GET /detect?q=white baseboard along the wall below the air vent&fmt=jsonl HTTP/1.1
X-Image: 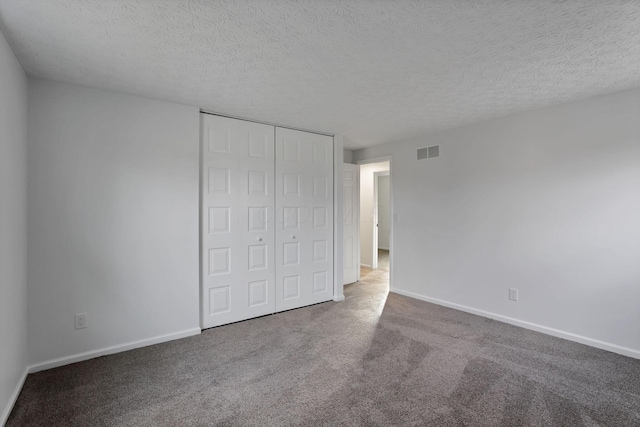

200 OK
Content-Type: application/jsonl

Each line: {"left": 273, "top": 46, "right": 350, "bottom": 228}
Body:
{"left": 392, "top": 289, "right": 640, "bottom": 359}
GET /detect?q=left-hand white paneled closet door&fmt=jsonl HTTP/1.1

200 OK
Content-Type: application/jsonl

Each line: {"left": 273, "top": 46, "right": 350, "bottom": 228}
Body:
{"left": 200, "top": 114, "right": 275, "bottom": 328}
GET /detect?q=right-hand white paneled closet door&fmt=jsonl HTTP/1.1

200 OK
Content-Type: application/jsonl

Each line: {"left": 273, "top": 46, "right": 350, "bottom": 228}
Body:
{"left": 276, "top": 127, "right": 333, "bottom": 311}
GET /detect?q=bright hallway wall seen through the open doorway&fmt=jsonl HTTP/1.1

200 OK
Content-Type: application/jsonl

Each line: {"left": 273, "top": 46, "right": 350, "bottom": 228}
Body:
{"left": 360, "top": 162, "right": 389, "bottom": 267}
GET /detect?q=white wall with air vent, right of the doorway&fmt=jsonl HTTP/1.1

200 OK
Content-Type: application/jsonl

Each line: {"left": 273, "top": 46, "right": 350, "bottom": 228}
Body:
{"left": 354, "top": 90, "right": 640, "bottom": 357}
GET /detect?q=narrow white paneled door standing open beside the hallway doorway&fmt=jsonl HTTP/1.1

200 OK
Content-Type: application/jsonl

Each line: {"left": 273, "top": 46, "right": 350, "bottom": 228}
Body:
{"left": 342, "top": 163, "right": 360, "bottom": 285}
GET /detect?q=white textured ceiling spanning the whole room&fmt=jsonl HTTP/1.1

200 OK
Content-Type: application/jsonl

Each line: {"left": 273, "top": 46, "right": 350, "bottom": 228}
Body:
{"left": 0, "top": 0, "right": 640, "bottom": 148}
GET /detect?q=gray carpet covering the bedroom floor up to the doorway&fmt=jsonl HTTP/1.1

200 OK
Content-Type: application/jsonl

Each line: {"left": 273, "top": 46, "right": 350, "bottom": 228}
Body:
{"left": 8, "top": 260, "right": 640, "bottom": 426}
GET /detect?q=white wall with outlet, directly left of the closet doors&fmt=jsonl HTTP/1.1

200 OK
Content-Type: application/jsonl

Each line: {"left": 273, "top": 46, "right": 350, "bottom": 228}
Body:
{"left": 28, "top": 79, "right": 199, "bottom": 369}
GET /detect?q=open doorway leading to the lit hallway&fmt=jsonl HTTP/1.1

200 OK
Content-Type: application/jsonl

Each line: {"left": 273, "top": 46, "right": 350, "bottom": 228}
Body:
{"left": 359, "top": 160, "right": 392, "bottom": 286}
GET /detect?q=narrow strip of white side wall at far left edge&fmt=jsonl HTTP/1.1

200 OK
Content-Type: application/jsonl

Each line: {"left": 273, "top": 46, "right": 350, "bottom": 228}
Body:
{"left": 0, "top": 27, "right": 27, "bottom": 425}
